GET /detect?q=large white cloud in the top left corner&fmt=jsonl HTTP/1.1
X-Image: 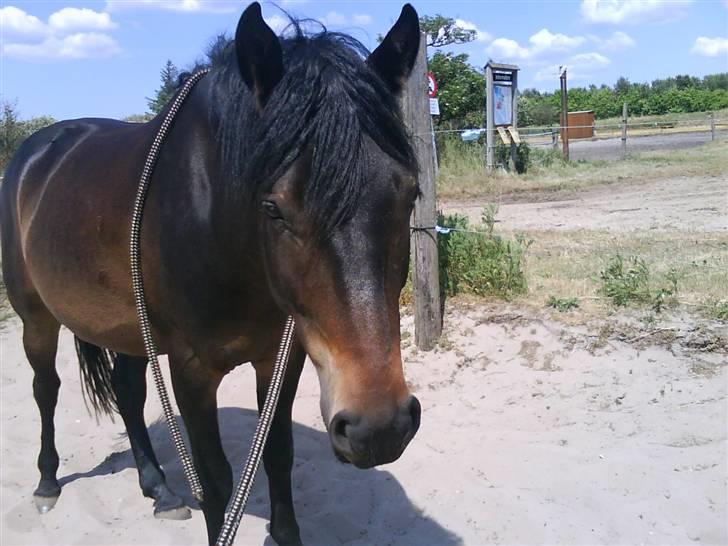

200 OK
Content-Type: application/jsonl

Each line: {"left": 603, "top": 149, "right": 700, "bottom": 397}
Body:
{"left": 0, "top": 6, "right": 121, "bottom": 59}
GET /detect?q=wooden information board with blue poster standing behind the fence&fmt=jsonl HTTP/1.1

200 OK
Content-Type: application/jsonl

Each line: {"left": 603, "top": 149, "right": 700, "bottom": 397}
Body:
{"left": 485, "top": 61, "right": 519, "bottom": 172}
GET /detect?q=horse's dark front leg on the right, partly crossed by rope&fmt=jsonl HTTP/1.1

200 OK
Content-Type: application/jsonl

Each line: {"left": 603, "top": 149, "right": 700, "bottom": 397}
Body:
{"left": 253, "top": 342, "right": 306, "bottom": 546}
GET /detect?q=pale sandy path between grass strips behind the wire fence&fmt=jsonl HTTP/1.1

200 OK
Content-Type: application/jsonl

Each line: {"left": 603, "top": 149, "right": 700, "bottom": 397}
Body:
{"left": 442, "top": 173, "right": 728, "bottom": 234}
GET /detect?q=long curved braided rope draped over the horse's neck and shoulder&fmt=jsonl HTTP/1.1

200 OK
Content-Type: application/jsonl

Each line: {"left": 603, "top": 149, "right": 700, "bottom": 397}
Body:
{"left": 129, "top": 70, "right": 208, "bottom": 502}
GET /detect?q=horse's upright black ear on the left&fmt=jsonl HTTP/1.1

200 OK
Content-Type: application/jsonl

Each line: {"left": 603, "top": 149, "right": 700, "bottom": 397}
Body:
{"left": 235, "top": 2, "right": 283, "bottom": 108}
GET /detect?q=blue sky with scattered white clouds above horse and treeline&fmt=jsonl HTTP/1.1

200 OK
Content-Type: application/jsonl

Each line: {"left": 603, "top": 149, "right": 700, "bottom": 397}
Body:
{"left": 0, "top": 0, "right": 728, "bottom": 119}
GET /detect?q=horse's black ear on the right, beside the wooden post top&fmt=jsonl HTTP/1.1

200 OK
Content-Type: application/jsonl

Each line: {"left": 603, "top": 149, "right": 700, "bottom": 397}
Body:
{"left": 367, "top": 4, "right": 420, "bottom": 94}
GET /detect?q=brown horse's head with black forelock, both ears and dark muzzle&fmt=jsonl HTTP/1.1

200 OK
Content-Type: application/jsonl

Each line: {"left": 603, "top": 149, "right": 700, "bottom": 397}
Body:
{"left": 235, "top": 4, "right": 420, "bottom": 468}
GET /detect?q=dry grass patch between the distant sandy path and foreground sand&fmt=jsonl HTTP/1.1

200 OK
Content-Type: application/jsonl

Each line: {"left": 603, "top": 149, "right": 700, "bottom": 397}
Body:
{"left": 525, "top": 230, "right": 728, "bottom": 318}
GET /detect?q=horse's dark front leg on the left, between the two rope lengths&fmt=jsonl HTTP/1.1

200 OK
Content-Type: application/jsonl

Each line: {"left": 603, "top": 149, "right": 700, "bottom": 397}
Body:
{"left": 170, "top": 355, "right": 233, "bottom": 544}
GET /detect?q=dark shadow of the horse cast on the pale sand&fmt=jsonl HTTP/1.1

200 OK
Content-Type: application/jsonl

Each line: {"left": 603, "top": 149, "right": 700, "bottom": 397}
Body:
{"left": 60, "top": 408, "right": 463, "bottom": 546}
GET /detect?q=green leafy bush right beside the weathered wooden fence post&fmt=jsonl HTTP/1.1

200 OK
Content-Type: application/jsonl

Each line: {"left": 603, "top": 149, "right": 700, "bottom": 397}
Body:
{"left": 438, "top": 206, "right": 532, "bottom": 299}
